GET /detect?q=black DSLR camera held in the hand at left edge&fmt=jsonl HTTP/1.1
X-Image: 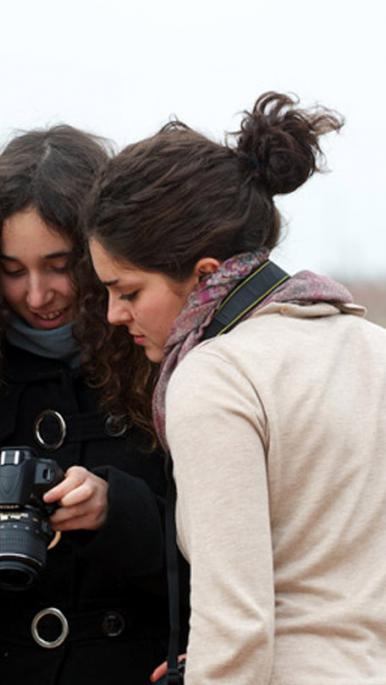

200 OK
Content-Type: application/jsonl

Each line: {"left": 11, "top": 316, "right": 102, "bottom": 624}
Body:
{"left": 0, "top": 447, "right": 64, "bottom": 590}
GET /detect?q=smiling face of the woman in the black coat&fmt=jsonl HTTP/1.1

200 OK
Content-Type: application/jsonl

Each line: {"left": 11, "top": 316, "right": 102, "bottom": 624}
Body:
{"left": 0, "top": 208, "right": 75, "bottom": 330}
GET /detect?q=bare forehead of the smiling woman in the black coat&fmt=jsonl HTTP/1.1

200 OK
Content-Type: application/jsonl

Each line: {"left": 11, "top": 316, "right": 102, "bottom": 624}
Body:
{"left": 1, "top": 208, "right": 72, "bottom": 258}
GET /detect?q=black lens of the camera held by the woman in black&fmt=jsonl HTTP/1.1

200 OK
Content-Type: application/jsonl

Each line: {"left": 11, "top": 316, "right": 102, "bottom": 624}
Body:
{"left": 0, "top": 506, "right": 53, "bottom": 590}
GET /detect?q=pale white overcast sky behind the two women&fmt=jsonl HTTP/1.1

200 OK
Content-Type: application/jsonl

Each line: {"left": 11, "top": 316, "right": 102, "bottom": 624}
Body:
{"left": 0, "top": 0, "right": 386, "bottom": 279}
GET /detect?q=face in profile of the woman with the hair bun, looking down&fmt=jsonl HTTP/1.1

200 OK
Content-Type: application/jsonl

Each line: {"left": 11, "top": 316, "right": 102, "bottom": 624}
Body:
{"left": 90, "top": 239, "right": 198, "bottom": 362}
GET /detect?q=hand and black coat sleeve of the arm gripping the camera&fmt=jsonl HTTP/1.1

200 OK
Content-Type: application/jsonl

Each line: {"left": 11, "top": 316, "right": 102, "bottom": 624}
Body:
{"left": 44, "top": 466, "right": 164, "bottom": 576}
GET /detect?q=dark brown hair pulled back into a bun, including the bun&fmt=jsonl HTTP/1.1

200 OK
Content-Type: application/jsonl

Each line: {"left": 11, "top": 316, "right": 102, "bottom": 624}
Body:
{"left": 86, "top": 93, "right": 342, "bottom": 280}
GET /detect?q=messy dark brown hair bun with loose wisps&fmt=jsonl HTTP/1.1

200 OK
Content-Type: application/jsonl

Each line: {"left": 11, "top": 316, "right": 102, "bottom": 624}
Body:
{"left": 236, "top": 92, "right": 343, "bottom": 196}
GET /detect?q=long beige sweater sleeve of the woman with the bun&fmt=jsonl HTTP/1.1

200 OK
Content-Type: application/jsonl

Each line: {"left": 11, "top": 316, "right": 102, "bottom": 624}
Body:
{"left": 166, "top": 346, "right": 274, "bottom": 685}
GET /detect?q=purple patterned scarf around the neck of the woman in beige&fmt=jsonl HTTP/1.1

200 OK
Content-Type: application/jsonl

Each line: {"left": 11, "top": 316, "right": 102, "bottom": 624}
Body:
{"left": 153, "top": 250, "right": 352, "bottom": 448}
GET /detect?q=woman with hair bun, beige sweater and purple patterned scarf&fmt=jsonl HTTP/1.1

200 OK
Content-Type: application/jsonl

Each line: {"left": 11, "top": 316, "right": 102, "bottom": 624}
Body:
{"left": 87, "top": 93, "right": 386, "bottom": 685}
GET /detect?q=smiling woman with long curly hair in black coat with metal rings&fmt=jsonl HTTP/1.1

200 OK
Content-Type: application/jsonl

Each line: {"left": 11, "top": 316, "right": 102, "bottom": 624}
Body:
{"left": 0, "top": 125, "right": 173, "bottom": 685}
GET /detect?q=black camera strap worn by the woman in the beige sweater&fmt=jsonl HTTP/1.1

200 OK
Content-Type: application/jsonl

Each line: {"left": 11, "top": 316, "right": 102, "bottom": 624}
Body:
{"left": 160, "top": 260, "right": 290, "bottom": 685}
